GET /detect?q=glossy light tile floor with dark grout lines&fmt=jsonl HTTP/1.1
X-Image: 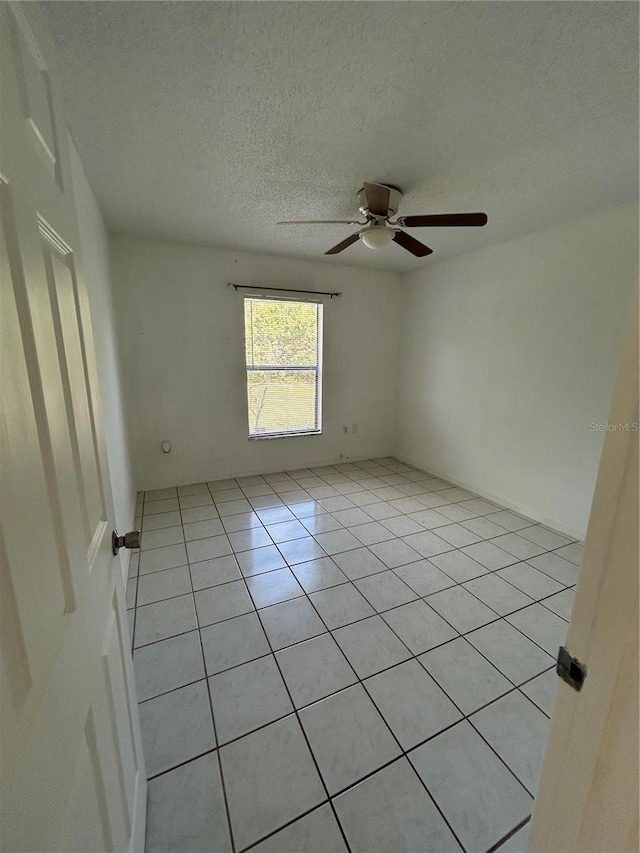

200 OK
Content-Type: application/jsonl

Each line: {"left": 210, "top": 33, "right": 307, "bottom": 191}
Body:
{"left": 127, "top": 458, "right": 581, "bottom": 853}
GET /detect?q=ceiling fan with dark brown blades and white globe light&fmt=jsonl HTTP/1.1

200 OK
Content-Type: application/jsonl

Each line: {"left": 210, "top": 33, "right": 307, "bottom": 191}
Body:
{"left": 277, "top": 182, "right": 487, "bottom": 258}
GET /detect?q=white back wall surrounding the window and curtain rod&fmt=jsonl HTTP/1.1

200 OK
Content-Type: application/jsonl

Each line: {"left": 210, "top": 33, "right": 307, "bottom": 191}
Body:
{"left": 111, "top": 236, "right": 400, "bottom": 489}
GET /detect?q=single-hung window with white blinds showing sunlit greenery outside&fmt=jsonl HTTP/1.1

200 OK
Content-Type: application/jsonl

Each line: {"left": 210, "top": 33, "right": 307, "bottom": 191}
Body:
{"left": 244, "top": 296, "right": 322, "bottom": 438}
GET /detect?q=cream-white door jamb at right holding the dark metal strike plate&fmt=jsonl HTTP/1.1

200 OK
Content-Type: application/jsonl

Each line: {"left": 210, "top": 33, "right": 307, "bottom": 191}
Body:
{"left": 529, "top": 292, "right": 639, "bottom": 853}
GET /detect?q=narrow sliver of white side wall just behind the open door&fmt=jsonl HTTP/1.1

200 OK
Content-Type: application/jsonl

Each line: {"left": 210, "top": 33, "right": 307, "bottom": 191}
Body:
{"left": 69, "top": 143, "right": 135, "bottom": 565}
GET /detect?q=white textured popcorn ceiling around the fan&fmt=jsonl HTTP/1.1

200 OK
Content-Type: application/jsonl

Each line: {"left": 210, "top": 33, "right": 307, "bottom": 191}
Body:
{"left": 45, "top": 2, "right": 638, "bottom": 271}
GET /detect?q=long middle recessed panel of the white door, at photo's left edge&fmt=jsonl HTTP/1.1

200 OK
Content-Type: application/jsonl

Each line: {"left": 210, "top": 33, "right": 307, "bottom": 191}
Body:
{"left": 0, "top": 176, "right": 75, "bottom": 704}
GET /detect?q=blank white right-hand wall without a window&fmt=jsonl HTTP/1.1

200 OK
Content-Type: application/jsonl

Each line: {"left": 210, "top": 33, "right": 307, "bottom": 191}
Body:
{"left": 395, "top": 205, "right": 638, "bottom": 538}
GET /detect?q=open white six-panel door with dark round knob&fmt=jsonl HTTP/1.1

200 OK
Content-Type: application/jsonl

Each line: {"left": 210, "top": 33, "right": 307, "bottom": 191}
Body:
{"left": 0, "top": 3, "right": 146, "bottom": 853}
